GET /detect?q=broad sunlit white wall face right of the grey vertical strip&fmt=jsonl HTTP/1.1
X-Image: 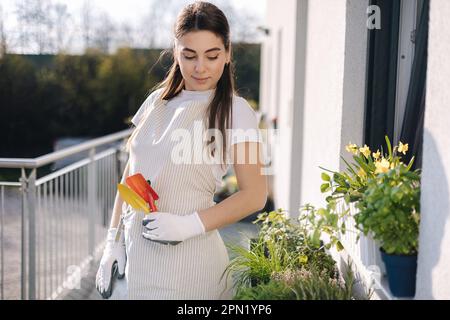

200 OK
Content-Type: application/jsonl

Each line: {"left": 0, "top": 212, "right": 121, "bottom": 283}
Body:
{"left": 298, "top": 0, "right": 346, "bottom": 205}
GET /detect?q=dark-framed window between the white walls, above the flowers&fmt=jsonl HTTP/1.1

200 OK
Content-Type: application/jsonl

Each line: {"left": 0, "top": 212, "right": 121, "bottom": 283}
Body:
{"left": 364, "top": 0, "right": 429, "bottom": 167}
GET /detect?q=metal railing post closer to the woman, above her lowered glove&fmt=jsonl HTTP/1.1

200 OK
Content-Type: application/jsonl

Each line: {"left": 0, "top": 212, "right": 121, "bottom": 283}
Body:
{"left": 87, "top": 148, "right": 97, "bottom": 258}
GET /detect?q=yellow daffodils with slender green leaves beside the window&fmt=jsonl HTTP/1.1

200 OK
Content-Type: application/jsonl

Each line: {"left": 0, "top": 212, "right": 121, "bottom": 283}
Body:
{"left": 320, "top": 136, "right": 414, "bottom": 204}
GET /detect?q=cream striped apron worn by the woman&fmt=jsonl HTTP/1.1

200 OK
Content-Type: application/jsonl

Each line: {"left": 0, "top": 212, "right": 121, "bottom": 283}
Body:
{"left": 115, "top": 94, "right": 232, "bottom": 299}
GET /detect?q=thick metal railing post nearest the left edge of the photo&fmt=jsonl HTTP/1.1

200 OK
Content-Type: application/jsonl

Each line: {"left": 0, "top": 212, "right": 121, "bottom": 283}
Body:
{"left": 27, "top": 169, "right": 36, "bottom": 300}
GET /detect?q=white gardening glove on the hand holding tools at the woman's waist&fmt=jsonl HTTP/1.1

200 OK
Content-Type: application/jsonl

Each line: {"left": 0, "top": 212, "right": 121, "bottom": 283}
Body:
{"left": 142, "top": 212, "right": 205, "bottom": 245}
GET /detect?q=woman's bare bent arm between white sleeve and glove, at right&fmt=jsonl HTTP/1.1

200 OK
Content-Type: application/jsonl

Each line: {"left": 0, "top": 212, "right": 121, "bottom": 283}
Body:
{"left": 198, "top": 142, "right": 267, "bottom": 231}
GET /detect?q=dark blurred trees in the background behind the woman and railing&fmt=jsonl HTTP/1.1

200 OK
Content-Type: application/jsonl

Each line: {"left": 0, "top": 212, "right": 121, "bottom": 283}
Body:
{"left": 0, "top": 44, "right": 260, "bottom": 157}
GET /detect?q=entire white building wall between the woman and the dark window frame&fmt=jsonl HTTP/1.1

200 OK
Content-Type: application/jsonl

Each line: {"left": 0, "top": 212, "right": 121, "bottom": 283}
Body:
{"left": 261, "top": 0, "right": 368, "bottom": 215}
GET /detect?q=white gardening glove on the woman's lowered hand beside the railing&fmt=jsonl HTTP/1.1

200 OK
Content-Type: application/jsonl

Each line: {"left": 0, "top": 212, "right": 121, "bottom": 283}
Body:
{"left": 95, "top": 228, "right": 126, "bottom": 299}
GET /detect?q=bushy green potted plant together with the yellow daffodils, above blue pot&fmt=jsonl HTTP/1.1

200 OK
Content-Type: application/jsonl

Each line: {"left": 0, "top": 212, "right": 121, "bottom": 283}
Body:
{"left": 318, "top": 136, "right": 420, "bottom": 254}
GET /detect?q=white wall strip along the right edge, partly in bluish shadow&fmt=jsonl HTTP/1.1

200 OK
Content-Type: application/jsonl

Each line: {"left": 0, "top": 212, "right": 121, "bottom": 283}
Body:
{"left": 416, "top": 0, "right": 450, "bottom": 299}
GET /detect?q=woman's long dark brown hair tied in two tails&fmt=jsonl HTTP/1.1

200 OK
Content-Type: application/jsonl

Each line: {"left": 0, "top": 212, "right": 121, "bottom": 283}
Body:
{"left": 157, "top": 1, "right": 234, "bottom": 163}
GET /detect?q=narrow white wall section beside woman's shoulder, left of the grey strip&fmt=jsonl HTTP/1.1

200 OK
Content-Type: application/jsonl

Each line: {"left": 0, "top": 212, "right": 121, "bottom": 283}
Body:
{"left": 260, "top": 0, "right": 297, "bottom": 209}
